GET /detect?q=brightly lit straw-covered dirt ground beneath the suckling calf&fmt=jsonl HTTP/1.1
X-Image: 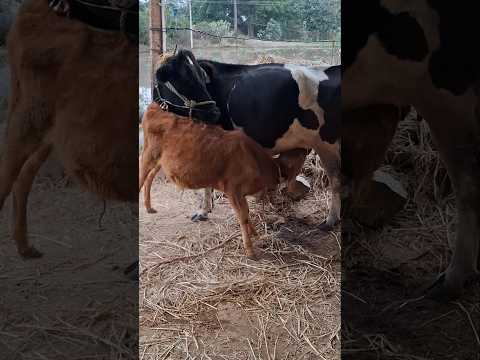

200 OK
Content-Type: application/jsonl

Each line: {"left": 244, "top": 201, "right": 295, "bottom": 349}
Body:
{"left": 140, "top": 159, "right": 340, "bottom": 360}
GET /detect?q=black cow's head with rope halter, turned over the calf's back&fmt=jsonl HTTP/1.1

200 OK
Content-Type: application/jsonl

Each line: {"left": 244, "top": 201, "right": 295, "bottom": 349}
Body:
{"left": 154, "top": 50, "right": 220, "bottom": 123}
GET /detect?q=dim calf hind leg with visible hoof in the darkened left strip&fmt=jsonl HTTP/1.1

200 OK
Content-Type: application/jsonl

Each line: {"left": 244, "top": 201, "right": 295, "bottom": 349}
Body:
{"left": 12, "top": 145, "right": 51, "bottom": 258}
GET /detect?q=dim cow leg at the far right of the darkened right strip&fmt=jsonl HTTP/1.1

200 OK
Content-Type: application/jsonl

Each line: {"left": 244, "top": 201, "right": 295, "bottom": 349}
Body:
{"left": 423, "top": 107, "right": 480, "bottom": 300}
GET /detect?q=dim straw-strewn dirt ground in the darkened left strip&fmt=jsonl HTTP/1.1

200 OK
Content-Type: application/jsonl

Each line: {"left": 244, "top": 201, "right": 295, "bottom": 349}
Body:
{"left": 0, "top": 50, "right": 138, "bottom": 360}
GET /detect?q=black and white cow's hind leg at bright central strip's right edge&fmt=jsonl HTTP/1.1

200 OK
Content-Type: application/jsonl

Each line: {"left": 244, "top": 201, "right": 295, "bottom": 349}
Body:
{"left": 314, "top": 141, "right": 341, "bottom": 231}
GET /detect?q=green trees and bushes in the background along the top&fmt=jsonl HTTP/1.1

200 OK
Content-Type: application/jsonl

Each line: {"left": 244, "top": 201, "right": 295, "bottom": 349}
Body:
{"left": 140, "top": 0, "right": 342, "bottom": 43}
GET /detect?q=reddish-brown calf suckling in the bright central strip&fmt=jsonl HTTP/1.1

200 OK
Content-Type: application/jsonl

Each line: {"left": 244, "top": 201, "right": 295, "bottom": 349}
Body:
{"left": 139, "top": 103, "right": 286, "bottom": 258}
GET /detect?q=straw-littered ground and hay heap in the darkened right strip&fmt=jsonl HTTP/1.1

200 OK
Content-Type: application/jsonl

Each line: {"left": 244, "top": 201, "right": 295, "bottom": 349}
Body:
{"left": 342, "top": 114, "right": 480, "bottom": 360}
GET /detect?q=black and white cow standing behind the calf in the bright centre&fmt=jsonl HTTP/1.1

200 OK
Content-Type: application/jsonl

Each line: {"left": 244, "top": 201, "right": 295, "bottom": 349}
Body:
{"left": 156, "top": 50, "right": 341, "bottom": 228}
